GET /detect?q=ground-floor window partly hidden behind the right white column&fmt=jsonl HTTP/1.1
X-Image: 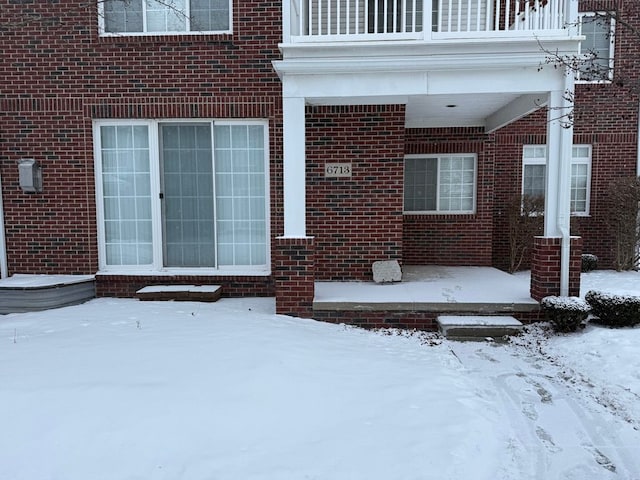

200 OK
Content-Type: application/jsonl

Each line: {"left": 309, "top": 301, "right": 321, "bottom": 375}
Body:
{"left": 522, "top": 145, "right": 591, "bottom": 215}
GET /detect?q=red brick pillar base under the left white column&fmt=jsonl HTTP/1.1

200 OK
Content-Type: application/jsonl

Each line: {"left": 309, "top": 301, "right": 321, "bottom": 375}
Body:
{"left": 275, "top": 237, "right": 315, "bottom": 318}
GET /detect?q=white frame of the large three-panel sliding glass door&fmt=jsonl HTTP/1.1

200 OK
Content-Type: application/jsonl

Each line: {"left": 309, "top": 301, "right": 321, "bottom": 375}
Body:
{"left": 93, "top": 118, "right": 271, "bottom": 275}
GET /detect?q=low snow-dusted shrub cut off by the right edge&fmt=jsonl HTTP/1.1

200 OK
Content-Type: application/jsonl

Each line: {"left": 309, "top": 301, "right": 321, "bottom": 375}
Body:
{"left": 585, "top": 290, "right": 640, "bottom": 327}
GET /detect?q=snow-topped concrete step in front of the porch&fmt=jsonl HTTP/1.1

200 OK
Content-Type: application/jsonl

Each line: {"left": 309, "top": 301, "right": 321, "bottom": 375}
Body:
{"left": 436, "top": 315, "right": 522, "bottom": 340}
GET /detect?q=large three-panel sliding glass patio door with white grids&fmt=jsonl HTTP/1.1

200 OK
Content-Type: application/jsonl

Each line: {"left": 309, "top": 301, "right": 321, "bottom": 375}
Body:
{"left": 94, "top": 121, "right": 269, "bottom": 270}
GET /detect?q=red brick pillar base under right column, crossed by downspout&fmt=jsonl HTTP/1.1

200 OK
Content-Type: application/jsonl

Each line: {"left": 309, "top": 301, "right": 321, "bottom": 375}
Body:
{"left": 531, "top": 237, "right": 582, "bottom": 301}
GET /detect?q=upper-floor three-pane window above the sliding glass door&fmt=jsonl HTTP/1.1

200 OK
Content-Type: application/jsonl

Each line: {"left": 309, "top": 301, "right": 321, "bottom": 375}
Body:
{"left": 98, "top": 0, "right": 231, "bottom": 35}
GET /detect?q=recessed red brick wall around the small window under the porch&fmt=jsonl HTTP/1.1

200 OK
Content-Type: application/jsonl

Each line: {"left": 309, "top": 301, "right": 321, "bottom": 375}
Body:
{"left": 403, "top": 128, "right": 495, "bottom": 266}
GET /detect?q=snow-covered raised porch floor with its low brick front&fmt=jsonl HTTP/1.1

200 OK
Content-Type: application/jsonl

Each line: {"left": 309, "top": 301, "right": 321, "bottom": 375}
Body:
{"left": 312, "top": 265, "right": 542, "bottom": 330}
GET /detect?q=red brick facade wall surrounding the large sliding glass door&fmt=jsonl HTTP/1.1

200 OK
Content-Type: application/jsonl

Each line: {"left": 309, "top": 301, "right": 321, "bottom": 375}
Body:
{"left": 0, "top": 0, "right": 282, "bottom": 288}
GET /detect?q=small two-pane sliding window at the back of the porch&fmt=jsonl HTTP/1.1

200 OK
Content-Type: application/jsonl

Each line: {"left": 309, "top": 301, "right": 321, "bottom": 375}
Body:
{"left": 404, "top": 154, "right": 476, "bottom": 213}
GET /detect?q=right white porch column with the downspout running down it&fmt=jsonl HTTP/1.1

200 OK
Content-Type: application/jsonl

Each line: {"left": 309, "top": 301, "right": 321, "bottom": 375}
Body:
{"left": 544, "top": 86, "right": 573, "bottom": 296}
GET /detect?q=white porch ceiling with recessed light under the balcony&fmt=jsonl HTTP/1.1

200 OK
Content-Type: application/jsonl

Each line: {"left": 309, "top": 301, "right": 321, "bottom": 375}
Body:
{"left": 405, "top": 92, "right": 547, "bottom": 131}
